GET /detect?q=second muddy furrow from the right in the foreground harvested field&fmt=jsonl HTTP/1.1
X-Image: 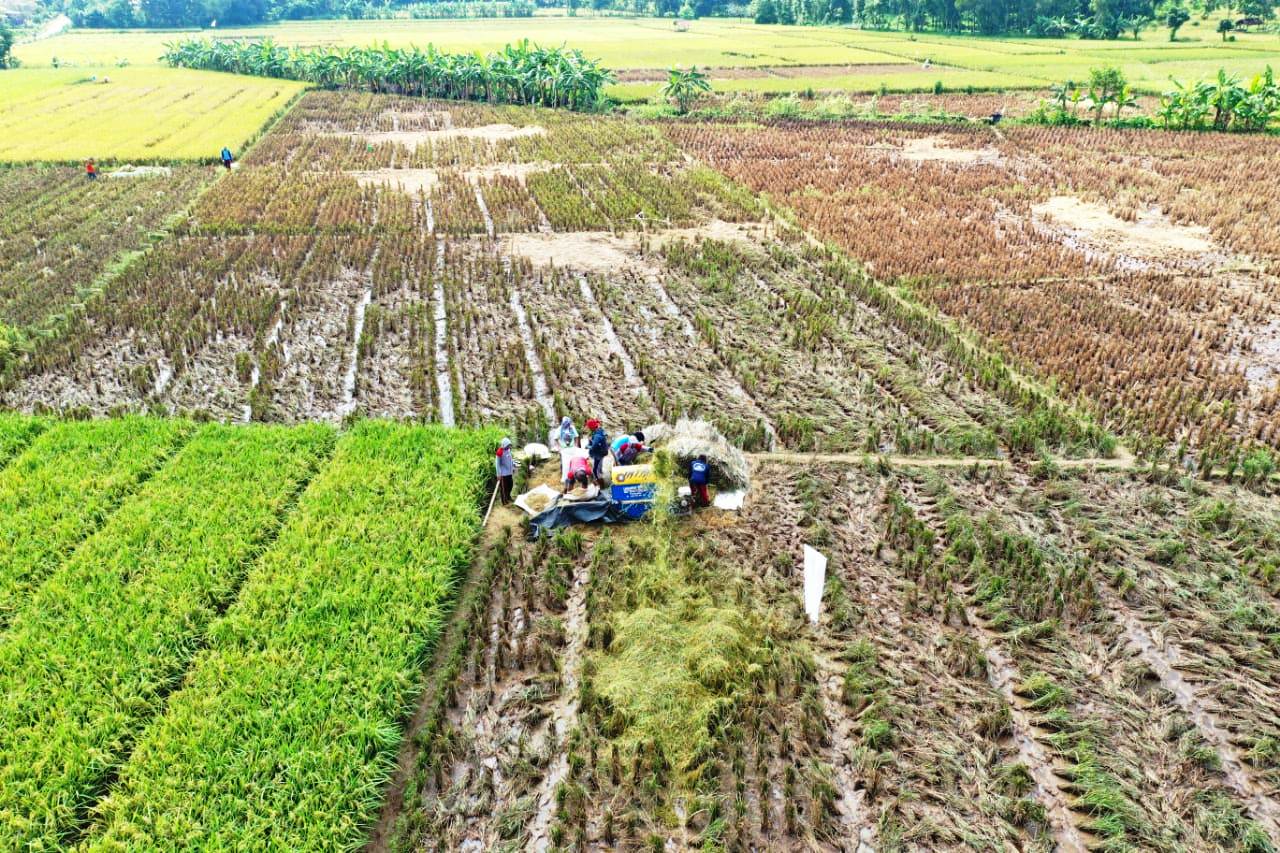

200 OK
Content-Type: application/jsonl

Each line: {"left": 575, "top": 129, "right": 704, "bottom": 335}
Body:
{"left": 965, "top": 607, "right": 1089, "bottom": 853}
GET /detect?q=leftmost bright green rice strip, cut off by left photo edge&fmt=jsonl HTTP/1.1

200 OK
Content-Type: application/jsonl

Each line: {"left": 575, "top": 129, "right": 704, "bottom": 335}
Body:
{"left": 0, "top": 418, "right": 191, "bottom": 626}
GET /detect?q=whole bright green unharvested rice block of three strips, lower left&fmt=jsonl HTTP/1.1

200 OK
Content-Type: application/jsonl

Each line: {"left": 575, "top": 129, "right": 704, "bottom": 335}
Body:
{"left": 0, "top": 415, "right": 497, "bottom": 849}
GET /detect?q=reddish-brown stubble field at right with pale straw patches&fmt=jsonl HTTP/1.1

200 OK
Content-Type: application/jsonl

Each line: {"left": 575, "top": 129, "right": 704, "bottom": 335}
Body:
{"left": 669, "top": 122, "right": 1280, "bottom": 461}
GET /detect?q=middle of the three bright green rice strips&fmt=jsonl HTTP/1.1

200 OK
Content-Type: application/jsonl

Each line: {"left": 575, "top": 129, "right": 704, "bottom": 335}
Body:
{"left": 0, "top": 417, "right": 333, "bottom": 847}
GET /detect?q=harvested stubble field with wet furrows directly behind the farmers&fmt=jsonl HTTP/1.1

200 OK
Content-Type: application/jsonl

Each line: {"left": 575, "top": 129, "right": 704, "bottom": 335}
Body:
{"left": 0, "top": 92, "right": 1107, "bottom": 456}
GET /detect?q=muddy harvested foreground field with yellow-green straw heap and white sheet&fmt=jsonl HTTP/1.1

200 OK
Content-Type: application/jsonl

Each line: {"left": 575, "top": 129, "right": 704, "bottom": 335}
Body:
{"left": 374, "top": 461, "right": 1280, "bottom": 850}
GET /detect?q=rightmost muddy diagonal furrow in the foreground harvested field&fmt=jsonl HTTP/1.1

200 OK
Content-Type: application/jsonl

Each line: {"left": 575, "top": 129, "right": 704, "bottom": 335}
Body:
{"left": 1100, "top": 584, "right": 1280, "bottom": 838}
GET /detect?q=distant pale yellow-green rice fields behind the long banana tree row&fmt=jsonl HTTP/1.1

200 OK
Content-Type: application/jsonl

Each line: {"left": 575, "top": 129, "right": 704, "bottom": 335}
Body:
{"left": 17, "top": 17, "right": 1280, "bottom": 99}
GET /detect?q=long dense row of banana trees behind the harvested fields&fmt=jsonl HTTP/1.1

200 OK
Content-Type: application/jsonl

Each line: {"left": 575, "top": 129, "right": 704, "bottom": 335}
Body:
{"left": 164, "top": 38, "right": 614, "bottom": 110}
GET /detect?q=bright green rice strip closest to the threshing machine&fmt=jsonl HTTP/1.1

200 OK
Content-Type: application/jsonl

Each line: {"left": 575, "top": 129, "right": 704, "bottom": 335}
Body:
{"left": 86, "top": 421, "right": 499, "bottom": 850}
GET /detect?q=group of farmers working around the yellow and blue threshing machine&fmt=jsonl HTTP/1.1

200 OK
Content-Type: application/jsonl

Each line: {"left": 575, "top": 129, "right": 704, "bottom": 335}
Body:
{"left": 494, "top": 415, "right": 710, "bottom": 506}
